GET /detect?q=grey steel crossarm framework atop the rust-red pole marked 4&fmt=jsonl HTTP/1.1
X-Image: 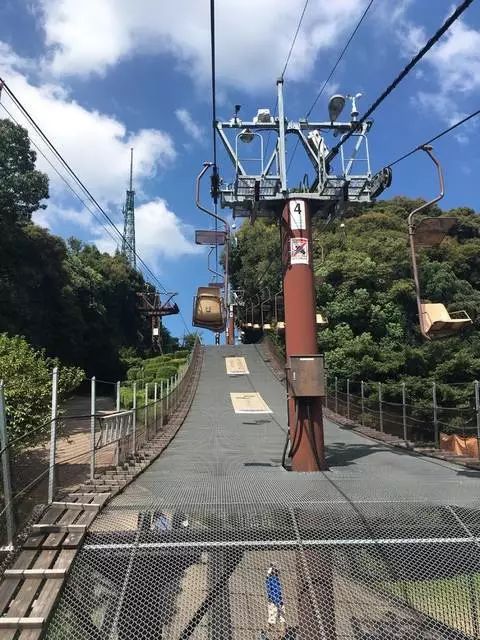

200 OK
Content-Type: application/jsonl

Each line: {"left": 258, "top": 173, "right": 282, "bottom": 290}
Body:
{"left": 213, "top": 80, "right": 391, "bottom": 217}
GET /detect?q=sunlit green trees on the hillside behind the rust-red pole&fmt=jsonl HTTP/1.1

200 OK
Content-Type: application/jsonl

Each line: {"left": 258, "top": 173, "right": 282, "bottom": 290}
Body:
{"left": 231, "top": 198, "right": 480, "bottom": 404}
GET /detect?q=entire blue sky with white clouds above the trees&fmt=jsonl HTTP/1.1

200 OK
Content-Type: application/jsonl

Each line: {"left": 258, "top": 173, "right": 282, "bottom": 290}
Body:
{"left": 0, "top": 0, "right": 480, "bottom": 342}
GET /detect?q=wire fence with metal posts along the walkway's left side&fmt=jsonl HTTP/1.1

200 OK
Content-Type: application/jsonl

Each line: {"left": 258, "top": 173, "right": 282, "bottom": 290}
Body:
{"left": 0, "top": 342, "right": 200, "bottom": 563}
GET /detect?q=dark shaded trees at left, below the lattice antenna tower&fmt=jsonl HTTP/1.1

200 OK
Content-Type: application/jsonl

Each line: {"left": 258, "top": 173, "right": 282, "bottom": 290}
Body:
{"left": 0, "top": 120, "right": 174, "bottom": 379}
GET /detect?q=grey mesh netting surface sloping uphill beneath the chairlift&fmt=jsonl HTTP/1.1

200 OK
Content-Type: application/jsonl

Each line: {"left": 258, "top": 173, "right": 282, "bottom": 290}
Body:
{"left": 46, "top": 345, "right": 480, "bottom": 640}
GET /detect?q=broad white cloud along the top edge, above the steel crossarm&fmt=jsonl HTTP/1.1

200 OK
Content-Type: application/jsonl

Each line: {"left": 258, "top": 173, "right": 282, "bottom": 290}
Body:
{"left": 37, "top": 0, "right": 372, "bottom": 90}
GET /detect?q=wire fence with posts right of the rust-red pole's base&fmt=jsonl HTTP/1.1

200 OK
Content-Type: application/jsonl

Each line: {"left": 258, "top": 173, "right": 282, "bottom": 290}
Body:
{"left": 325, "top": 377, "right": 480, "bottom": 458}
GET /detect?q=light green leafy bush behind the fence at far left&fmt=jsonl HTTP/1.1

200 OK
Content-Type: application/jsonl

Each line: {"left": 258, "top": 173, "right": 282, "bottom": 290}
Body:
{"left": 0, "top": 333, "right": 83, "bottom": 448}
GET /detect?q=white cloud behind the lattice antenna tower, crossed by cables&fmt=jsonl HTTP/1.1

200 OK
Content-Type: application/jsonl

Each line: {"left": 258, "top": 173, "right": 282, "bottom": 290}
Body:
{"left": 0, "top": 43, "right": 197, "bottom": 265}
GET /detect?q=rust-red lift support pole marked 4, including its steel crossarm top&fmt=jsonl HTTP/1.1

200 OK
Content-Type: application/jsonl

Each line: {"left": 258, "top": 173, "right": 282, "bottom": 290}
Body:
{"left": 207, "top": 78, "right": 391, "bottom": 471}
